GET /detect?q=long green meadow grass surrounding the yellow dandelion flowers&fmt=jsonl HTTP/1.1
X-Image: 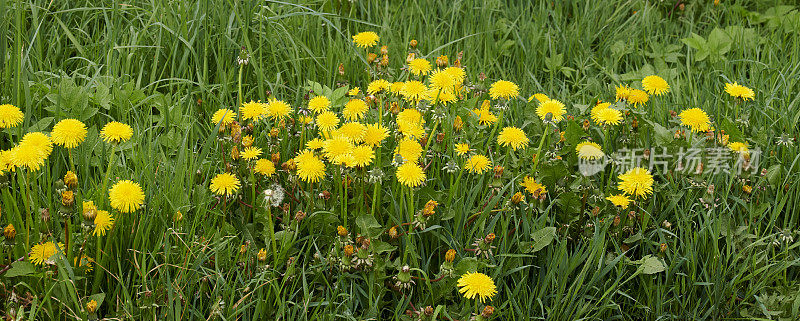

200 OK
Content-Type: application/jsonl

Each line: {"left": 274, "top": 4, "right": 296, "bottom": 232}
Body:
{"left": 0, "top": 0, "right": 800, "bottom": 320}
